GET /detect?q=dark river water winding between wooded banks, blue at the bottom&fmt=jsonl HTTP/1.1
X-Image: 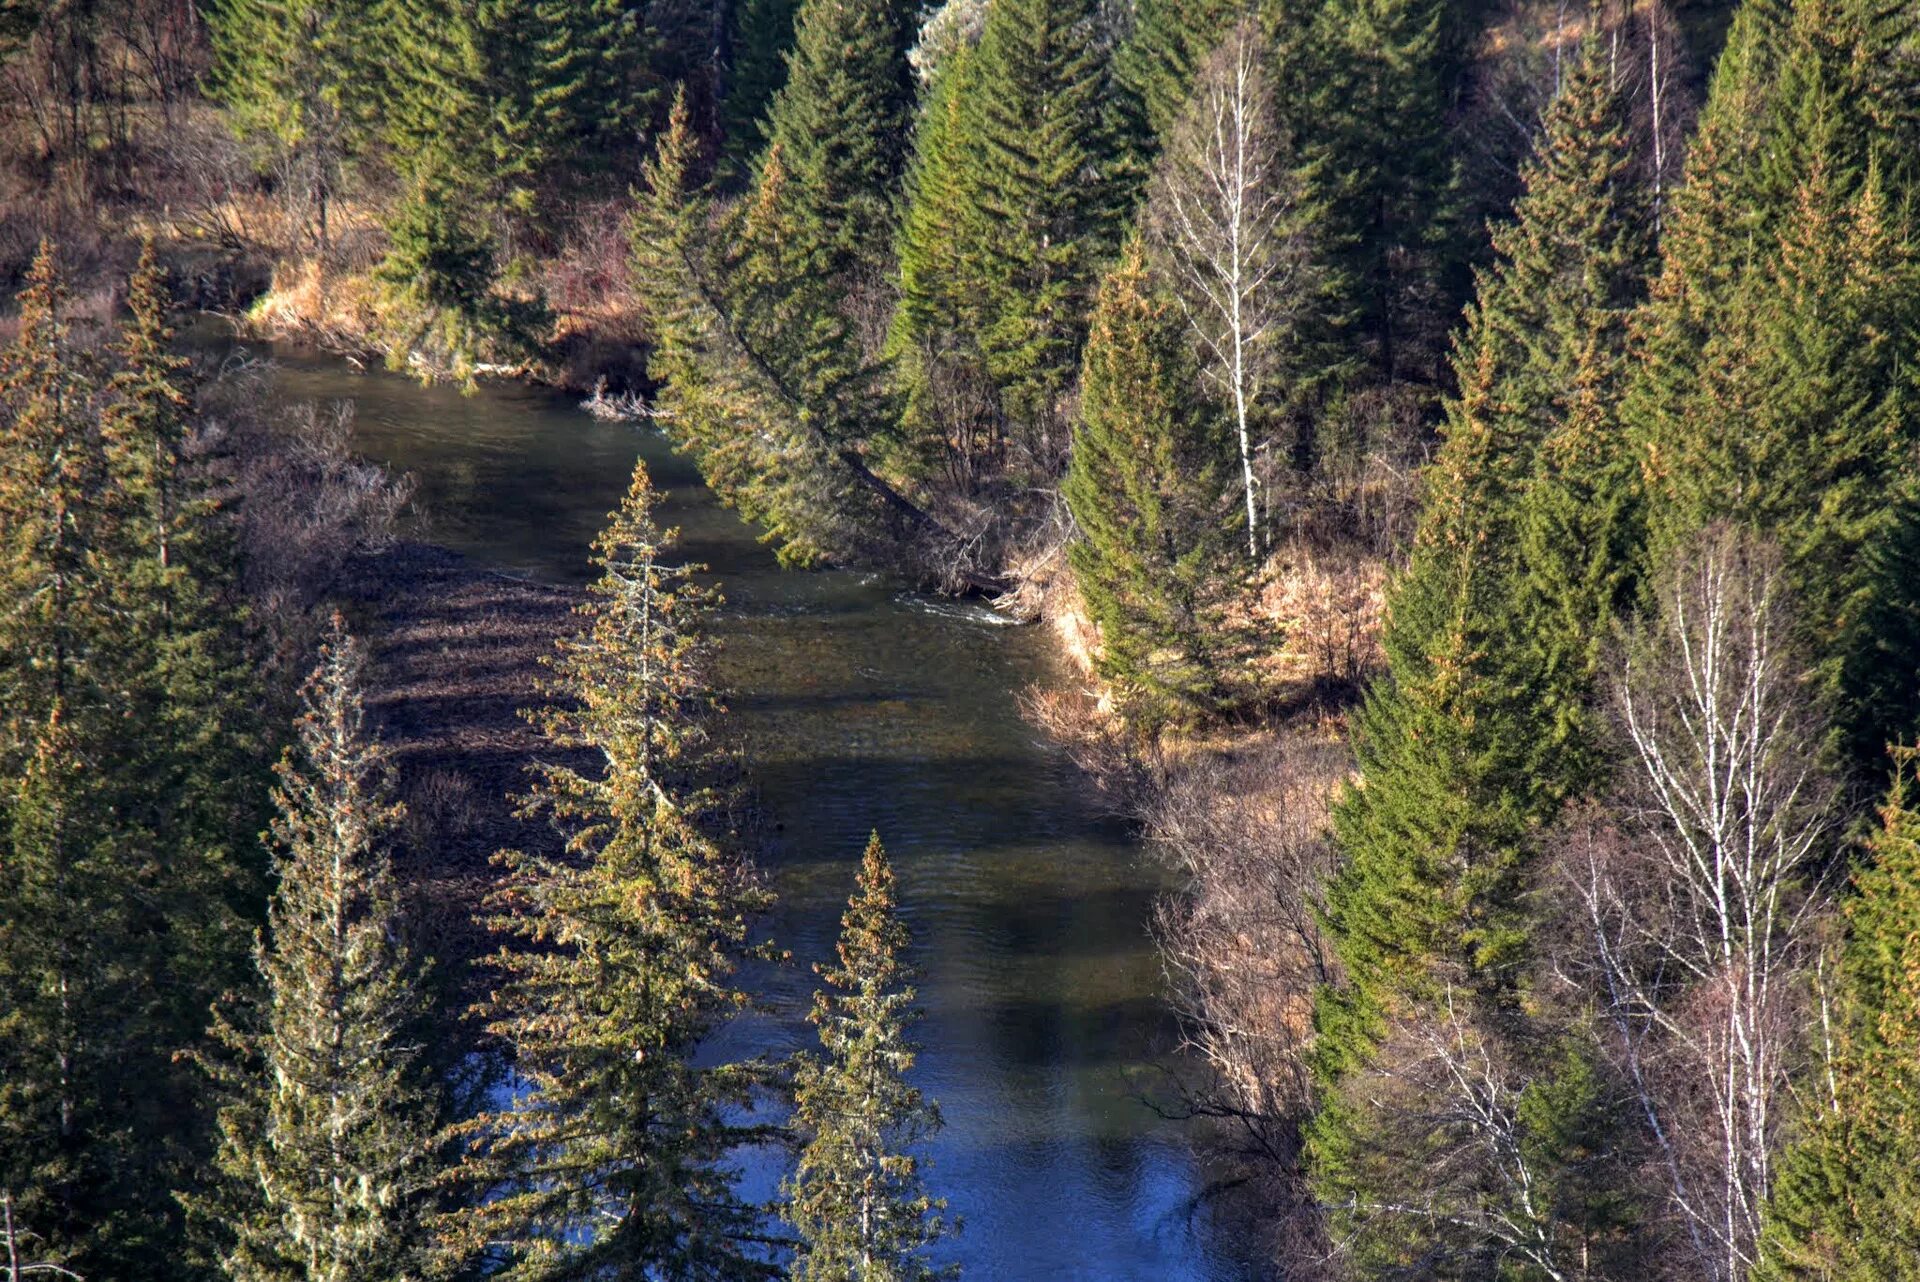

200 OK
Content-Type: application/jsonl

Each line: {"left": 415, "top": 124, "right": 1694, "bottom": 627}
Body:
{"left": 255, "top": 351, "right": 1233, "bottom": 1282}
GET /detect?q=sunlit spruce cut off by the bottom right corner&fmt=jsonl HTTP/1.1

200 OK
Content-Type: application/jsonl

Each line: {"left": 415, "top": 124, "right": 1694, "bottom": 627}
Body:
{"left": 1753, "top": 748, "right": 1920, "bottom": 1282}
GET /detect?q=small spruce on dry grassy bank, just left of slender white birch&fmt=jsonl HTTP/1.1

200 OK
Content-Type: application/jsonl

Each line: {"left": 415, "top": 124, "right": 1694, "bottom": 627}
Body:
{"left": 1062, "top": 244, "right": 1235, "bottom": 725}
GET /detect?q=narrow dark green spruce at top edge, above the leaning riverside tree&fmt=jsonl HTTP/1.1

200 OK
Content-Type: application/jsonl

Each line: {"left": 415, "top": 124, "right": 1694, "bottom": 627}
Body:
{"left": 748, "top": 0, "right": 912, "bottom": 290}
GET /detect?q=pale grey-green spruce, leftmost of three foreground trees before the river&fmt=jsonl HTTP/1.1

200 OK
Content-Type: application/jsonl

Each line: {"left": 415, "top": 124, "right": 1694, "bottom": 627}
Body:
{"left": 194, "top": 614, "right": 440, "bottom": 1282}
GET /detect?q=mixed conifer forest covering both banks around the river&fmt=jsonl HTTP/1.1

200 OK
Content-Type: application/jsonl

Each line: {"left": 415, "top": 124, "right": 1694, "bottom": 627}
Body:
{"left": 0, "top": 0, "right": 1920, "bottom": 1282}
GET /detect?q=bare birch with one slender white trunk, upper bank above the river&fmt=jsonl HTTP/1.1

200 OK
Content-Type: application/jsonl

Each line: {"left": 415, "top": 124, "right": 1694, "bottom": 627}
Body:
{"left": 1146, "top": 17, "right": 1315, "bottom": 560}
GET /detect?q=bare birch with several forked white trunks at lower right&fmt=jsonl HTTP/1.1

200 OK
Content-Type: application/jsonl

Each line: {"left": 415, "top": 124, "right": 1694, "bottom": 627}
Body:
{"left": 1561, "top": 530, "right": 1843, "bottom": 1282}
